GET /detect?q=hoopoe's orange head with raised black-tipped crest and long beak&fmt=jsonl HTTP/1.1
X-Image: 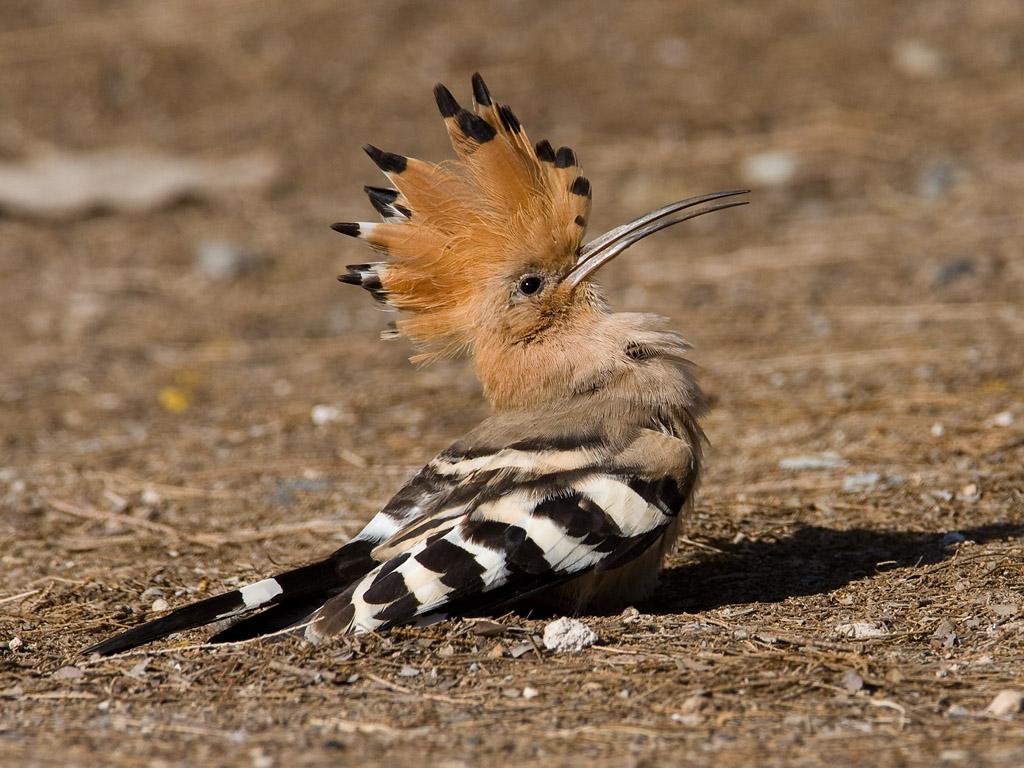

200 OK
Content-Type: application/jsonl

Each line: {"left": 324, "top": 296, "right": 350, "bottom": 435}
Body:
{"left": 333, "top": 75, "right": 742, "bottom": 404}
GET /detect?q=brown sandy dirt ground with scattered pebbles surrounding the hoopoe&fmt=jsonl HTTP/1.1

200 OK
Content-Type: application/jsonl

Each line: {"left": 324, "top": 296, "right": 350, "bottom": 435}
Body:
{"left": 0, "top": 0, "right": 1024, "bottom": 768}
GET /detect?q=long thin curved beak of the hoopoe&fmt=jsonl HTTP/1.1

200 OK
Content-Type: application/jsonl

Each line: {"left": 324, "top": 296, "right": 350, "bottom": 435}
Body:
{"left": 562, "top": 189, "right": 750, "bottom": 291}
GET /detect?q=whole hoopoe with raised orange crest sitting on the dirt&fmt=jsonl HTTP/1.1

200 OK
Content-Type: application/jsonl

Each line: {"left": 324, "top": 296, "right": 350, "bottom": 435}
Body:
{"left": 85, "top": 75, "right": 746, "bottom": 654}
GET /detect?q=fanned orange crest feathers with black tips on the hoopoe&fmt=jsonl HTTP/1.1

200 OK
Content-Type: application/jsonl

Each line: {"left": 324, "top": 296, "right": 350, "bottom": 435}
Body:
{"left": 334, "top": 74, "right": 590, "bottom": 357}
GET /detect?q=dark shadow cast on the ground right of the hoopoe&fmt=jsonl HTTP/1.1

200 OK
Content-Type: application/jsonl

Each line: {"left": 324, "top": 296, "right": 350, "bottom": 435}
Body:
{"left": 651, "top": 523, "right": 1024, "bottom": 613}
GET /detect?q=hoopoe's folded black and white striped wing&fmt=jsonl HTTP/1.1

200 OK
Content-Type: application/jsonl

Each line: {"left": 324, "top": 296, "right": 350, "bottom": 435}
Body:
{"left": 306, "top": 430, "right": 696, "bottom": 642}
